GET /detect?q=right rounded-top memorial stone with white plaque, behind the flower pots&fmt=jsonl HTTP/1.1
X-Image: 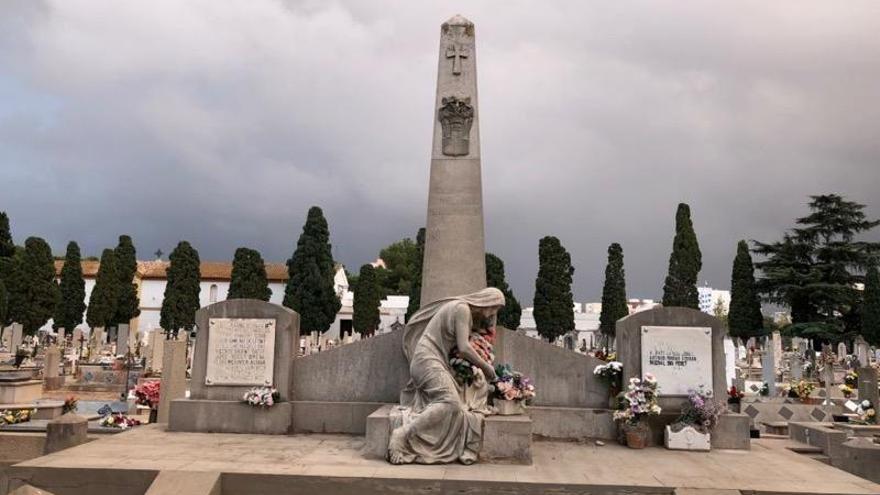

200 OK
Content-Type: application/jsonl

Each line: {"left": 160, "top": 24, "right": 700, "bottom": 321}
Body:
{"left": 615, "top": 307, "right": 749, "bottom": 449}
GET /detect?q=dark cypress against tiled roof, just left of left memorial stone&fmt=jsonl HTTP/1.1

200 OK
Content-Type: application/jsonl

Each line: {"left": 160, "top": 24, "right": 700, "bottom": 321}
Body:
{"left": 159, "top": 241, "right": 201, "bottom": 337}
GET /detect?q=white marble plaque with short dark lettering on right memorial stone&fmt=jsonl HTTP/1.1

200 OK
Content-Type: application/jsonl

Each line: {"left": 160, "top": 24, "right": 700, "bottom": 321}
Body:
{"left": 642, "top": 326, "right": 712, "bottom": 396}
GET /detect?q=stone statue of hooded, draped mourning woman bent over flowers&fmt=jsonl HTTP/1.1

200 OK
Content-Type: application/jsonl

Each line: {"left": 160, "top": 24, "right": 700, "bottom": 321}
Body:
{"left": 388, "top": 288, "right": 504, "bottom": 464}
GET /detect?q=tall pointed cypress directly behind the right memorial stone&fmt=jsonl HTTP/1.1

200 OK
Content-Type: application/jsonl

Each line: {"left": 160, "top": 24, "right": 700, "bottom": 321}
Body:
{"left": 663, "top": 203, "right": 703, "bottom": 309}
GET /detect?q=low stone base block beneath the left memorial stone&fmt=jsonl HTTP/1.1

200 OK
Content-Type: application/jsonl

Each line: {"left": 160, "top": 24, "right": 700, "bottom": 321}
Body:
{"left": 168, "top": 399, "right": 293, "bottom": 435}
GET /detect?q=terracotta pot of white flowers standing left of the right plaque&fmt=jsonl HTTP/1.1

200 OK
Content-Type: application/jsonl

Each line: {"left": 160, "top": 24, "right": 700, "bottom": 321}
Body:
{"left": 614, "top": 373, "right": 661, "bottom": 449}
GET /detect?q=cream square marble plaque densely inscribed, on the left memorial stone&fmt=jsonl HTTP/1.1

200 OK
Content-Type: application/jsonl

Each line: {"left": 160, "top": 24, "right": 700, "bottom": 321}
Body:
{"left": 205, "top": 318, "right": 275, "bottom": 387}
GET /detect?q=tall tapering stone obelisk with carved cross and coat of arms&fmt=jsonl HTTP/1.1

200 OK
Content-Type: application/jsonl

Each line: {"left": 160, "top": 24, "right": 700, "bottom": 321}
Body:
{"left": 421, "top": 15, "right": 486, "bottom": 306}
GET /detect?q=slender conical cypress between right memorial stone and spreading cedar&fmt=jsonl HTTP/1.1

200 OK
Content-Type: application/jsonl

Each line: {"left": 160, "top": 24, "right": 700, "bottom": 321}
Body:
{"left": 727, "top": 241, "right": 764, "bottom": 342}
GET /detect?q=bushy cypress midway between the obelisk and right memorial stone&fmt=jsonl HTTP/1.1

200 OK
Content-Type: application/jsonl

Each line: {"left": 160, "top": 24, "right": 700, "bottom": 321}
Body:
{"left": 534, "top": 236, "right": 574, "bottom": 342}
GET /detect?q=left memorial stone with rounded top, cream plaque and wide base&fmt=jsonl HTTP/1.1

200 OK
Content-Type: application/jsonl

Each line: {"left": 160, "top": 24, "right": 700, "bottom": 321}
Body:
{"left": 168, "top": 299, "right": 299, "bottom": 434}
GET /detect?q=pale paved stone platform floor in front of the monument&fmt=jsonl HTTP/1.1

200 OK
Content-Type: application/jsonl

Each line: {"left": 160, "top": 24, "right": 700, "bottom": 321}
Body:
{"left": 6, "top": 425, "right": 880, "bottom": 494}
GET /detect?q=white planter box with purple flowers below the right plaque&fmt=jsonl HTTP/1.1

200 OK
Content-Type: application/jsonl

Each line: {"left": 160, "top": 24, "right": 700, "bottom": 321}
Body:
{"left": 665, "top": 389, "right": 722, "bottom": 450}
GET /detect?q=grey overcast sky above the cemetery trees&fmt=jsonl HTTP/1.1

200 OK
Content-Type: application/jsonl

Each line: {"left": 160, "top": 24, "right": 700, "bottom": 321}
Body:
{"left": 0, "top": 0, "right": 880, "bottom": 306}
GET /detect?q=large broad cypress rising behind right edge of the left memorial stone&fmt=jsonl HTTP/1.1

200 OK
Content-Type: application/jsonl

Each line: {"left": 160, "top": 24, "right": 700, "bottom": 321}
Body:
{"left": 284, "top": 206, "right": 342, "bottom": 333}
